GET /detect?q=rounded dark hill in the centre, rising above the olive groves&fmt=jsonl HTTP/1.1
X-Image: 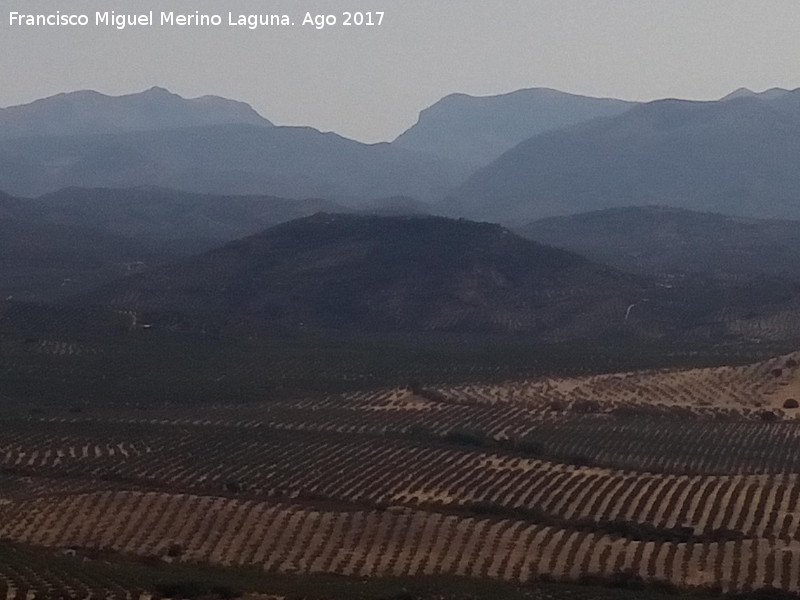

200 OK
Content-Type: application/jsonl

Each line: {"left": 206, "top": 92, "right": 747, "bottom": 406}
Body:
{"left": 80, "top": 213, "right": 647, "bottom": 335}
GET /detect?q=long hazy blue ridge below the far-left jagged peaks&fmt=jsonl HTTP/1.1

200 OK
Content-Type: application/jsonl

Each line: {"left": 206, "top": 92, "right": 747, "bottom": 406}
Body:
{"left": 0, "top": 124, "right": 470, "bottom": 203}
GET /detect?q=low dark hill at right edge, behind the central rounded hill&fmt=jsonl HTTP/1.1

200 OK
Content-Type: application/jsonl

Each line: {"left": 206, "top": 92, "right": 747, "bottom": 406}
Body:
{"left": 516, "top": 206, "right": 800, "bottom": 280}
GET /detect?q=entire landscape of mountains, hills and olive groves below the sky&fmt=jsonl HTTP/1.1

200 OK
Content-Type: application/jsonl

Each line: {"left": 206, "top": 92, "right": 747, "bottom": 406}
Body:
{"left": 0, "top": 88, "right": 800, "bottom": 600}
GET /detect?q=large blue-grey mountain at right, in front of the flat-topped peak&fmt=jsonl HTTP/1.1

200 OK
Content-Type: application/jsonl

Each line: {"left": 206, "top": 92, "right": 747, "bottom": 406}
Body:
{"left": 444, "top": 91, "right": 800, "bottom": 223}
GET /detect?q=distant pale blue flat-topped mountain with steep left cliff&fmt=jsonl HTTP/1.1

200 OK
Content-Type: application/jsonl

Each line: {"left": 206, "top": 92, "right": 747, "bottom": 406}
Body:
{"left": 393, "top": 88, "right": 636, "bottom": 167}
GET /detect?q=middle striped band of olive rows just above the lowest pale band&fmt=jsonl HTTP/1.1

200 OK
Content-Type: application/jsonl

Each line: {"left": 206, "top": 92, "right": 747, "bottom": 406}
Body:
{"left": 6, "top": 435, "right": 800, "bottom": 541}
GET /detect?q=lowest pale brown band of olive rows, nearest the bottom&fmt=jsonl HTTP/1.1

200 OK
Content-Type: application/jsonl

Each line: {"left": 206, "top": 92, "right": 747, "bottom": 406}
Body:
{"left": 0, "top": 492, "right": 800, "bottom": 591}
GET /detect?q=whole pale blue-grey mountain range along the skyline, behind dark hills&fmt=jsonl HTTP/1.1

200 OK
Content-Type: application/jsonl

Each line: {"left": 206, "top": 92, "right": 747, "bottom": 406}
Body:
{"left": 0, "top": 88, "right": 800, "bottom": 232}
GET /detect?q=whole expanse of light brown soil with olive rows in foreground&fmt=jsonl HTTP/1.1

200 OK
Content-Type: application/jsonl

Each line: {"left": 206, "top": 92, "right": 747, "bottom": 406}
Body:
{"left": 0, "top": 354, "right": 800, "bottom": 591}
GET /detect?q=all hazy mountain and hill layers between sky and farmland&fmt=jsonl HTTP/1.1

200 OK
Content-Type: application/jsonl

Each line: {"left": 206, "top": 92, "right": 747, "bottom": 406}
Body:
{"left": 0, "top": 83, "right": 800, "bottom": 339}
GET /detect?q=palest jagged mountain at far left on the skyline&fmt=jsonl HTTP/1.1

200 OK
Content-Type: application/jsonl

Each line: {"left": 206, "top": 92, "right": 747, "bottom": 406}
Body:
{"left": 0, "top": 87, "right": 272, "bottom": 139}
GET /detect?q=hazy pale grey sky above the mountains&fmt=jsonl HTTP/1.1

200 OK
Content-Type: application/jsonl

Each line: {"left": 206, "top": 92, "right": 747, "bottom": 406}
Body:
{"left": 0, "top": 0, "right": 800, "bottom": 142}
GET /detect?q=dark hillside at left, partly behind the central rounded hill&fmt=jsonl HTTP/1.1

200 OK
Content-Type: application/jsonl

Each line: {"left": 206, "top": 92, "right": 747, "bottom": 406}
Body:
{"left": 0, "top": 188, "right": 337, "bottom": 301}
